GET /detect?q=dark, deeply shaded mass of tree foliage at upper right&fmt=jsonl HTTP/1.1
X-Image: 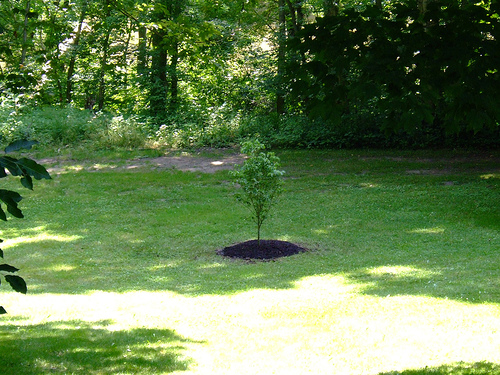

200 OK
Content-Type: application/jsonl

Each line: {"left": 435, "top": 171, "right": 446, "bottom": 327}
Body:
{"left": 290, "top": 0, "right": 500, "bottom": 132}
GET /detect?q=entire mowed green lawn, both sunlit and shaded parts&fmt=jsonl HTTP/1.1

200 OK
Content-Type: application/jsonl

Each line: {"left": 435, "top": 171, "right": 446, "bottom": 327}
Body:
{"left": 0, "top": 151, "right": 500, "bottom": 375}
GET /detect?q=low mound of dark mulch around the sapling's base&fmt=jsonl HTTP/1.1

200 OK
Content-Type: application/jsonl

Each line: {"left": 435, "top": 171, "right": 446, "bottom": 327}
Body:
{"left": 217, "top": 240, "right": 305, "bottom": 259}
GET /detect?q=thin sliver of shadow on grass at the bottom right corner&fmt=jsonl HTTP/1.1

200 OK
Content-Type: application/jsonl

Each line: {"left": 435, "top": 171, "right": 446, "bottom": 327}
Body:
{"left": 379, "top": 362, "right": 500, "bottom": 375}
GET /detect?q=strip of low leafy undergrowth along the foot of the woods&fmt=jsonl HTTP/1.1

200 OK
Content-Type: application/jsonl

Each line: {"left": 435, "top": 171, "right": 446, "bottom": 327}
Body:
{"left": 0, "top": 96, "right": 500, "bottom": 150}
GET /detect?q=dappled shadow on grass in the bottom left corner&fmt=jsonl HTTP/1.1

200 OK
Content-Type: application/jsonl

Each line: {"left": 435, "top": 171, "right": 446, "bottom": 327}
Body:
{"left": 0, "top": 321, "right": 195, "bottom": 375}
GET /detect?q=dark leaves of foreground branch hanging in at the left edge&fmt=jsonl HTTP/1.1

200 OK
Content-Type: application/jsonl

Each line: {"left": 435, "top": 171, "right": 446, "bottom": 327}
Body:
{"left": 0, "top": 141, "right": 50, "bottom": 314}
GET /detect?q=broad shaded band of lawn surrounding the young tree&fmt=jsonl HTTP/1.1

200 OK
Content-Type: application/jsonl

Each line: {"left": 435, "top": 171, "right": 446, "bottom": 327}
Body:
{"left": 2, "top": 159, "right": 500, "bottom": 303}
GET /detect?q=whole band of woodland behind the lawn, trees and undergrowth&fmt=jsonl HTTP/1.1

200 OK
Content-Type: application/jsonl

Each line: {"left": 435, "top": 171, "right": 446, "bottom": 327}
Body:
{"left": 0, "top": 0, "right": 500, "bottom": 148}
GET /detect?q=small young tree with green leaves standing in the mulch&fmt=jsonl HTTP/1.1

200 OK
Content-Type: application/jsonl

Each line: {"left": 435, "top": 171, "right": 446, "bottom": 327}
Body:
{"left": 232, "top": 140, "right": 285, "bottom": 242}
